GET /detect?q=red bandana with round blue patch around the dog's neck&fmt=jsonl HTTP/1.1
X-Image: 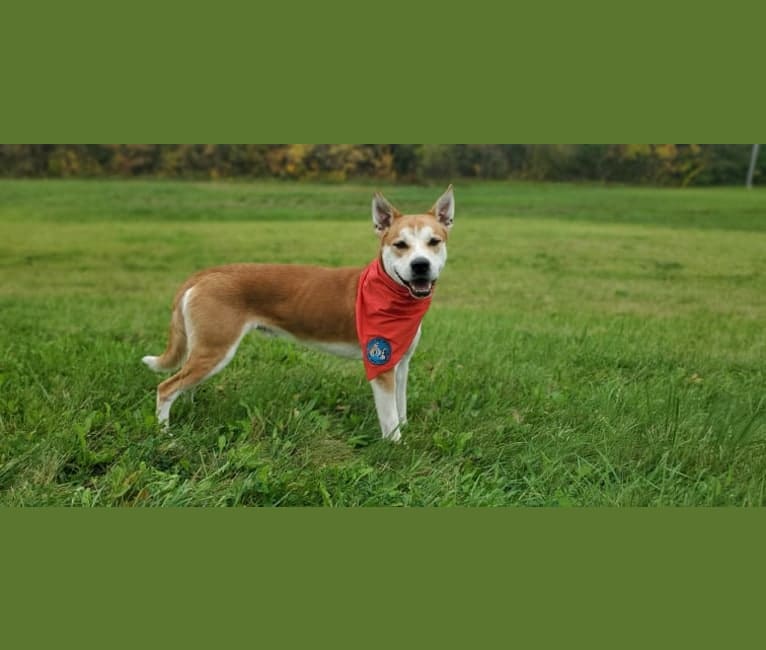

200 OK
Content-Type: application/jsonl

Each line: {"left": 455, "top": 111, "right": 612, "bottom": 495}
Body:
{"left": 356, "top": 259, "right": 431, "bottom": 380}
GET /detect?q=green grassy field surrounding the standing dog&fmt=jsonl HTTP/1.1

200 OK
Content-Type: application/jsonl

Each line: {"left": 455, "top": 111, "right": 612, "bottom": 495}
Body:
{"left": 0, "top": 180, "right": 766, "bottom": 506}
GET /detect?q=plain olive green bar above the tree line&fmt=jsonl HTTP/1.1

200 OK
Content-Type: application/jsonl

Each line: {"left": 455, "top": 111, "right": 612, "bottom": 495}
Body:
{"left": 0, "top": 0, "right": 766, "bottom": 143}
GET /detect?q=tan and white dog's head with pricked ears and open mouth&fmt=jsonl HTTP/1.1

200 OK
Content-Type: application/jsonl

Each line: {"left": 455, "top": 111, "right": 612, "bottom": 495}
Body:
{"left": 372, "top": 185, "right": 455, "bottom": 298}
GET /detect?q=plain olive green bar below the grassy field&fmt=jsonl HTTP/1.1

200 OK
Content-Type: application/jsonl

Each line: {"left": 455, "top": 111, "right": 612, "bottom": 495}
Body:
{"left": 0, "top": 509, "right": 766, "bottom": 648}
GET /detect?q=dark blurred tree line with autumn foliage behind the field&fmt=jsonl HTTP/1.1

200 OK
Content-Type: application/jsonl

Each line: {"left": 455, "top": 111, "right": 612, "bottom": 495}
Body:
{"left": 0, "top": 144, "right": 766, "bottom": 186}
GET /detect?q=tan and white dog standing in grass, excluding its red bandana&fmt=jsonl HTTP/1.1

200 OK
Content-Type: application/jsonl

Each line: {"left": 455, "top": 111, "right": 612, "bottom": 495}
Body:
{"left": 143, "top": 185, "right": 455, "bottom": 441}
